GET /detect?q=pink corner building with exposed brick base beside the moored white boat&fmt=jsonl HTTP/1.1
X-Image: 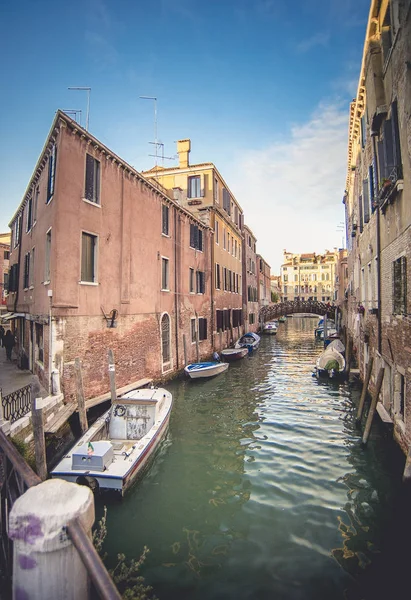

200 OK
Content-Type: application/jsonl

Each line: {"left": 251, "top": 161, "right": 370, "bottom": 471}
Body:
{"left": 8, "top": 111, "right": 212, "bottom": 399}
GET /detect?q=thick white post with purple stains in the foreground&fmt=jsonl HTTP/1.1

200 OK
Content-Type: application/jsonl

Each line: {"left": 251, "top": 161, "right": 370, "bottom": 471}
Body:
{"left": 9, "top": 479, "right": 94, "bottom": 600}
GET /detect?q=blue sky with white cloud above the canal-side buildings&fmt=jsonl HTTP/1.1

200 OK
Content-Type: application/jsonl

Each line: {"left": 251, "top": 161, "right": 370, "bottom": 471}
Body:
{"left": 0, "top": 0, "right": 370, "bottom": 273}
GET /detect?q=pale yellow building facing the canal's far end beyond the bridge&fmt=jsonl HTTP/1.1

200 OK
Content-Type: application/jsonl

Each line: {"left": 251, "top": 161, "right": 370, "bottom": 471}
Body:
{"left": 281, "top": 249, "right": 339, "bottom": 302}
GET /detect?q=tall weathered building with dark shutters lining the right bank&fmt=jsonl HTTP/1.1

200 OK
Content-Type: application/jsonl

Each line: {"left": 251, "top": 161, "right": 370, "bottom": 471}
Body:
{"left": 344, "top": 0, "right": 411, "bottom": 453}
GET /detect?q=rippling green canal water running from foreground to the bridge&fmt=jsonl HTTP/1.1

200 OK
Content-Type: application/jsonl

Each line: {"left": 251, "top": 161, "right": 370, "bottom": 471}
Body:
{"left": 97, "top": 318, "right": 410, "bottom": 600}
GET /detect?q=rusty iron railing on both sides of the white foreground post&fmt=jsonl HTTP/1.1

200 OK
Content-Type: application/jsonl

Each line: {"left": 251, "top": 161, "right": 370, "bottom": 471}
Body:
{"left": 0, "top": 430, "right": 121, "bottom": 600}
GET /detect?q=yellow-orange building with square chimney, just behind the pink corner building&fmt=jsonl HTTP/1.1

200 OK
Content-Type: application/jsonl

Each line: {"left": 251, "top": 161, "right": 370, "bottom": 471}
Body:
{"left": 143, "top": 139, "right": 244, "bottom": 349}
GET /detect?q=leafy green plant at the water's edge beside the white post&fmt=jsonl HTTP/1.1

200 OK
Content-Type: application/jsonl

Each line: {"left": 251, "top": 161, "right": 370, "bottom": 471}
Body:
{"left": 93, "top": 506, "right": 157, "bottom": 600}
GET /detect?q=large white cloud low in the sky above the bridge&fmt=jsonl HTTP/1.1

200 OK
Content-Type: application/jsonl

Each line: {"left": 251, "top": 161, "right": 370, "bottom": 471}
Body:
{"left": 228, "top": 103, "right": 348, "bottom": 274}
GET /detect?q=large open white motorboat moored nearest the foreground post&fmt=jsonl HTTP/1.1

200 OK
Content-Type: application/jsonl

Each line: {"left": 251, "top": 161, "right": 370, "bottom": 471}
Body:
{"left": 51, "top": 388, "right": 173, "bottom": 495}
